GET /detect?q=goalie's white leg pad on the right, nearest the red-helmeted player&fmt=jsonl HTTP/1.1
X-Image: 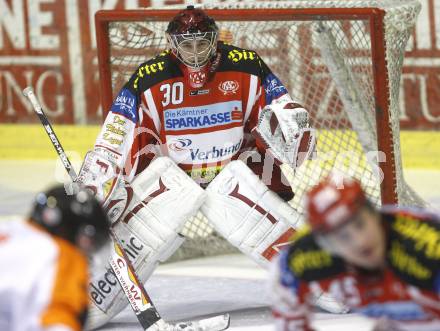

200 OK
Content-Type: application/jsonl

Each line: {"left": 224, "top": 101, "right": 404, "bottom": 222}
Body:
{"left": 201, "top": 161, "right": 302, "bottom": 267}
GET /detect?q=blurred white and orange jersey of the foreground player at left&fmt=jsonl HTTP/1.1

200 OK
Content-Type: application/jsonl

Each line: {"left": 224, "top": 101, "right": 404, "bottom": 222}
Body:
{"left": 0, "top": 220, "right": 88, "bottom": 331}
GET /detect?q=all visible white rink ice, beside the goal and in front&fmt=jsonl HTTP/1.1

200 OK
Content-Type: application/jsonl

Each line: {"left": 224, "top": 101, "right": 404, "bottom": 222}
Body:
{"left": 0, "top": 160, "right": 440, "bottom": 331}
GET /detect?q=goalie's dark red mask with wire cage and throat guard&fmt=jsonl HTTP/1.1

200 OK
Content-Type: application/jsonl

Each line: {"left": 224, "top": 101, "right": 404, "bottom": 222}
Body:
{"left": 166, "top": 6, "right": 218, "bottom": 88}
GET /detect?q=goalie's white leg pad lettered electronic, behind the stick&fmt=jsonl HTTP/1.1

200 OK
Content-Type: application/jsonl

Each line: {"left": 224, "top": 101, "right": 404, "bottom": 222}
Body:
{"left": 87, "top": 157, "right": 206, "bottom": 329}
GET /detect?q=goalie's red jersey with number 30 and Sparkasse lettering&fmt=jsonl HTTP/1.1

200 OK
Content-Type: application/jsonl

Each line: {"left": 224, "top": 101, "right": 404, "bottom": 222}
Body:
{"left": 95, "top": 43, "right": 298, "bottom": 195}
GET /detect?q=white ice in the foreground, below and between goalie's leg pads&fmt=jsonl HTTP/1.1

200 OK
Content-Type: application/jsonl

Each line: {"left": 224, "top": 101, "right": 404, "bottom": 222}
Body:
{"left": 95, "top": 254, "right": 372, "bottom": 331}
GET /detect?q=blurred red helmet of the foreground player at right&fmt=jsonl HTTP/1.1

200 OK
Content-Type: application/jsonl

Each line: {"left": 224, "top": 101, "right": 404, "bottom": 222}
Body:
{"left": 306, "top": 175, "right": 367, "bottom": 232}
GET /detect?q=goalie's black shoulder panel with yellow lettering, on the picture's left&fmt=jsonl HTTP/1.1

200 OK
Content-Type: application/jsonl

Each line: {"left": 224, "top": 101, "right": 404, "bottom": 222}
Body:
{"left": 132, "top": 50, "right": 181, "bottom": 90}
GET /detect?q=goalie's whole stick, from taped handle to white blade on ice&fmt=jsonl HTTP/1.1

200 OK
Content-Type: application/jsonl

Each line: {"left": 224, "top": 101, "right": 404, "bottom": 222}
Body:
{"left": 23, "top": 87, "right": 230, "bottom": 331}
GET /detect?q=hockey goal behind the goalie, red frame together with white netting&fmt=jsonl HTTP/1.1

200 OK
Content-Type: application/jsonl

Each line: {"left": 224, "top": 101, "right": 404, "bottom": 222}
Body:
{"left": 95, "top": 0, "right": 424, "bottom": 257}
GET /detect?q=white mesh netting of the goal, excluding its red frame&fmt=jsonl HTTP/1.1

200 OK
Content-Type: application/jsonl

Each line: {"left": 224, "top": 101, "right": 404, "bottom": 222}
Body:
{"left": 99, "top": 0, "right": 423, "bottom": 255}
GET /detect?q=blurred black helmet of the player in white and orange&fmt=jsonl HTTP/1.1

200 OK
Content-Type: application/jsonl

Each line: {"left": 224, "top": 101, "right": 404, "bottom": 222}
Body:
{"left": 30, "top": 185, "right": 109, "bottom": 253}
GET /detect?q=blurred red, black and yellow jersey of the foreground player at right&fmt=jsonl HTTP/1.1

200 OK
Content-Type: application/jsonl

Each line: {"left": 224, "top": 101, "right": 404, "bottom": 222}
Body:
{"left": 270, "top": 208, "right": 440, "bottom": 331}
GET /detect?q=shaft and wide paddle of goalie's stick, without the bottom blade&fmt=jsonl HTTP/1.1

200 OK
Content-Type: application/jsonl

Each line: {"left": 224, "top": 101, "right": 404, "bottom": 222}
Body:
{"left": 23, "top": 87, "right": 161, "bottom": 329}
